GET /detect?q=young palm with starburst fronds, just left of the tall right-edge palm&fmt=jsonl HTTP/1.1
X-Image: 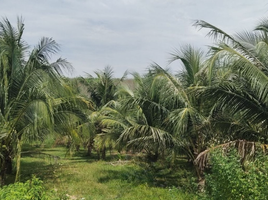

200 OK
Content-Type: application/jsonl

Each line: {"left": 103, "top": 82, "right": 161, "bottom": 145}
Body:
{"left": 149, "top": 61, "right": 211, "bottom": 176}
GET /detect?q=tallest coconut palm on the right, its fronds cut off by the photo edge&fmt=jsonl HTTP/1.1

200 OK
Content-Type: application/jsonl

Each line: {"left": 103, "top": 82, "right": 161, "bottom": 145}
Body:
{"left": 193, "top": 21, "right": 268, "bottom": 142}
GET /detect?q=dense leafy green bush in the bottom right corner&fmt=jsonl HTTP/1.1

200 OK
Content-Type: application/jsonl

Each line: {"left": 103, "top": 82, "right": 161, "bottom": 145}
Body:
{"left": 206, "top": 151, "right": 268, "bottom": 200}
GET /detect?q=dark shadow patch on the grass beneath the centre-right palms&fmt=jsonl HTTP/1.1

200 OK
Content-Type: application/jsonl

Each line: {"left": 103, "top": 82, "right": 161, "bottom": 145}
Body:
{"left": 98, "top": 159, "right": 196, "bottom": 191}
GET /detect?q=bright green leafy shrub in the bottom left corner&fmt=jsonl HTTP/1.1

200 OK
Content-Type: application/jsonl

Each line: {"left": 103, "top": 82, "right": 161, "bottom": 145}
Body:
{"left": 0, "top": 176, "right": 59, "bottom": 200}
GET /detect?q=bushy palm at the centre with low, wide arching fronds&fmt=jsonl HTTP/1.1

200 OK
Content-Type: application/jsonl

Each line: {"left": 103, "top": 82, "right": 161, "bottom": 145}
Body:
{"left": 115, "top": 69, "right": 174, "bottom": 161}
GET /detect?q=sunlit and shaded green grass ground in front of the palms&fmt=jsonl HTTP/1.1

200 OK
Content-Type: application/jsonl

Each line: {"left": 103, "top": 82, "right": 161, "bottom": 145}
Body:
{"left": 15, "top": 147, "right": 199, "bottom": 200}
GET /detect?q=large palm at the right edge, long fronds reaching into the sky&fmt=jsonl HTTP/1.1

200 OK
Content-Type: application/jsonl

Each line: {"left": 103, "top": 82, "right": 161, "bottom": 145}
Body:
{"left": 189, "top": 20, "right": 268, "bottom": 175}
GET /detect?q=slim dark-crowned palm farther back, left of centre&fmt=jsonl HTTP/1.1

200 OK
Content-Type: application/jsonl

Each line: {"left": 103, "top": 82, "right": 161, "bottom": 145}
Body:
{"left": 75, "top": 66, "right": 127, "bottom": 159}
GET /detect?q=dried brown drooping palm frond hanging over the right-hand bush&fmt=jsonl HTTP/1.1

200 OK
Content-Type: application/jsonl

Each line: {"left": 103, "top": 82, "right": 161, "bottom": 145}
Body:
{"left": 194, "top": 140, "right": 268, "bottom": 172}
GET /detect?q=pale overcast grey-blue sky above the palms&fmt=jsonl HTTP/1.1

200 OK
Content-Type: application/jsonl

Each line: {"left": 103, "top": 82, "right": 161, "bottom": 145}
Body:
{"left": 0, "top": 0, "right": 268, "bottom": 77}
